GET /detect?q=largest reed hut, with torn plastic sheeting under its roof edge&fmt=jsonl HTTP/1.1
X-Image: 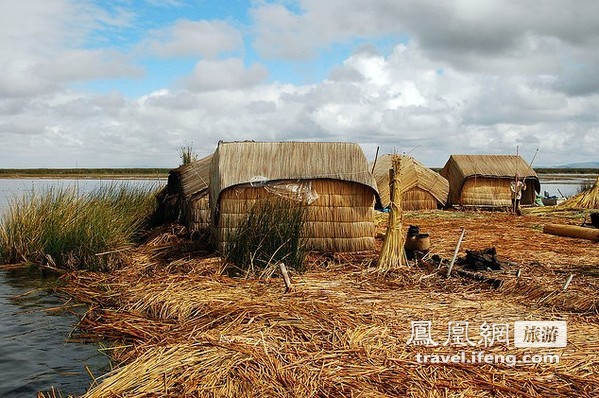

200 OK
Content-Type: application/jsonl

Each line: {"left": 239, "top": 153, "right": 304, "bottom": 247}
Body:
{"left": 210, "top": 142, "right": 378, "bottom": 252}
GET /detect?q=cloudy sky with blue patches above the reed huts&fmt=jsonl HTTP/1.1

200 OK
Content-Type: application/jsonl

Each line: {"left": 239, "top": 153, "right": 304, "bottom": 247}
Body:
{"left": 0, "top": 0, "right": 599, "bottom": 168}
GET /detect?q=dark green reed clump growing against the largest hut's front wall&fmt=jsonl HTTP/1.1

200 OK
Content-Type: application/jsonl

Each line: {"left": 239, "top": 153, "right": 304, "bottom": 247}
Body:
{"left": 225, "top": 199, "right": 306, "bottom": 274}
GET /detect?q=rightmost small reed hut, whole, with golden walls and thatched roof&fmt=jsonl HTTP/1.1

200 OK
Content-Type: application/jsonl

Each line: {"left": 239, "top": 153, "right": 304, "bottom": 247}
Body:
{"left": 439, "top": 155, "right": 541, "bottom": 208}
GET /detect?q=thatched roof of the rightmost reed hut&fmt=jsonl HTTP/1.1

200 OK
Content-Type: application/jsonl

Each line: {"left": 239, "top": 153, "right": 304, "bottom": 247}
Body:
{"left": 439, "top": 155, "right": 541, "bottom": 192}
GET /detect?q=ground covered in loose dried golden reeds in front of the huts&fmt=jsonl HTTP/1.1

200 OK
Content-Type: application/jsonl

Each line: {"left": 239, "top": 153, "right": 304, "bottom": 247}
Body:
{"left": 57, "top": 212, "right": 599, "bottom": 397}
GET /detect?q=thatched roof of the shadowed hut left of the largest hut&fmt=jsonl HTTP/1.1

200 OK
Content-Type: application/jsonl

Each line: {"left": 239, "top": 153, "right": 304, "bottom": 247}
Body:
{"left": 169, "top": 154, "right": 213, "bottom": 200}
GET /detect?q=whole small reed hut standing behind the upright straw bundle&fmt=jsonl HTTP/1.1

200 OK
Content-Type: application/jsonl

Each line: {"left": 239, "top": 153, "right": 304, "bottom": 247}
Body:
{"left": 370, "top": 155, "right": 449, "bottom": 210}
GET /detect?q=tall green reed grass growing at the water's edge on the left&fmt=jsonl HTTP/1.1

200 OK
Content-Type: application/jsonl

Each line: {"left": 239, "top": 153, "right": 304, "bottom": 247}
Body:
{"left": 0, "top": 184, "right": 156, "bottom": 270}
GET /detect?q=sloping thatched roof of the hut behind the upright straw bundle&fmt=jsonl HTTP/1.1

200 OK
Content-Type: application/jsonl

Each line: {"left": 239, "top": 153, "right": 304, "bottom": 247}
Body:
{"left": 371, "top": 155, "right": 449, "bottom": 206}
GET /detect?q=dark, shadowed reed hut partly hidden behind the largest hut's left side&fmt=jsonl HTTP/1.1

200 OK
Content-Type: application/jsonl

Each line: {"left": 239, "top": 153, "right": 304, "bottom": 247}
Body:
{"left": 163, "top": 155, "right": 212, "bottom": 232}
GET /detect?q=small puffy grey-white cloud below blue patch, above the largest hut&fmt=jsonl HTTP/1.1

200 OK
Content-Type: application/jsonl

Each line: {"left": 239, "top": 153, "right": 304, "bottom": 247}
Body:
{"left": 182, "top": 58, "right": 268, "bottom": 91}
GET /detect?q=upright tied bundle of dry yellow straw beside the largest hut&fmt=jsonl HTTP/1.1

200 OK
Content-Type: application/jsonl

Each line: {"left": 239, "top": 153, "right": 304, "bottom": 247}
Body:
{"left": 377, "top": 155, "right": 405, "bottom": 273}
